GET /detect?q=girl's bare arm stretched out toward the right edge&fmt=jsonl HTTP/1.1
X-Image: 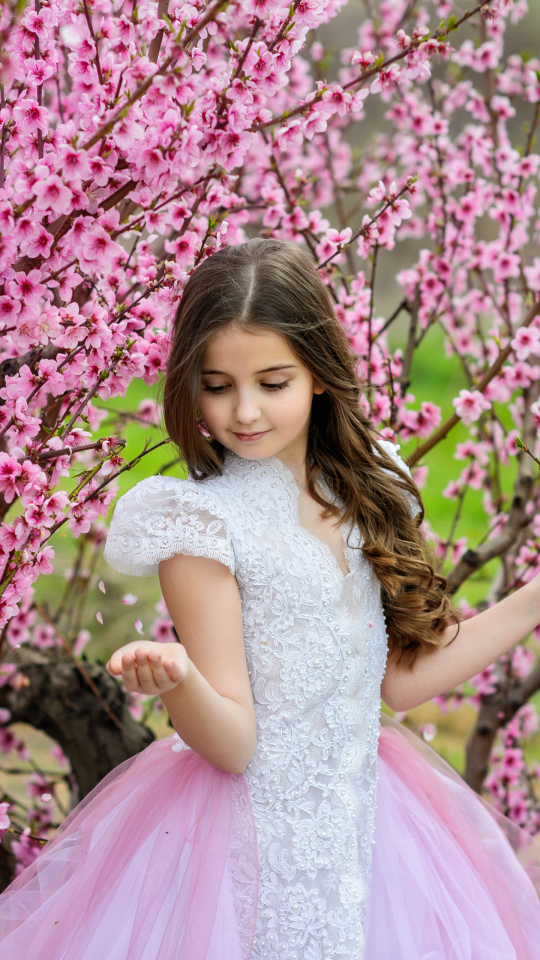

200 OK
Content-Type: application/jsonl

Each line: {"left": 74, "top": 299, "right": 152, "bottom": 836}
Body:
{"left": 382, "top": 575, "right": 540, "bottom": 711}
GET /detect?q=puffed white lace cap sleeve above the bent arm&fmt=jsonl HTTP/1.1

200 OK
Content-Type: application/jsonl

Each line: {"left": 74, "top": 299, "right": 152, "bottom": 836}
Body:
{"left": 104, "top": 476, "right": 235, "bottom": 577}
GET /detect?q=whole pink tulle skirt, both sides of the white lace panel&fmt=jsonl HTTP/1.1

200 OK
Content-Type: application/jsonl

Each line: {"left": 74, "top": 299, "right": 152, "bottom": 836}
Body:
{"left": 0, "top": 719, "right": 540, "bottom": 960}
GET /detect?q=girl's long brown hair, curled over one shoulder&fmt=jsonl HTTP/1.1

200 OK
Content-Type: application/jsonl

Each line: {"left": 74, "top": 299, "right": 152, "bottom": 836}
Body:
{"left": 164, "top": 239, "right": 455, "bottom": 666}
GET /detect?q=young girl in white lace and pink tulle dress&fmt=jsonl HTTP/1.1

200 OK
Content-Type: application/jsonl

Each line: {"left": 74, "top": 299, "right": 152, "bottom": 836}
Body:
{"left": 0, "top": 240, "right": 540, "bottom": 960}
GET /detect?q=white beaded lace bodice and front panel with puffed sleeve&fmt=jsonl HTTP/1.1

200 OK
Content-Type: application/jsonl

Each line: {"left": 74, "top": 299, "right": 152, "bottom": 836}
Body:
{"left": 105, "top": 443, "right": 414, "bottom": 960}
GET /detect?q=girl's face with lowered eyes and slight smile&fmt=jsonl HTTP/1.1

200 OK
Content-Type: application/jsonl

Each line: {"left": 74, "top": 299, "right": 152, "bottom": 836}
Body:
{"left": 199, "top": 324, "right": 324, "bottom": 461}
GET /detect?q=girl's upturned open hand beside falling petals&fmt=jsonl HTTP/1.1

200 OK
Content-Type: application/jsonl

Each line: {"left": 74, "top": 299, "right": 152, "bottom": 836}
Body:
{"left": 107, "top": 640, "right": 190, "bottom": 696}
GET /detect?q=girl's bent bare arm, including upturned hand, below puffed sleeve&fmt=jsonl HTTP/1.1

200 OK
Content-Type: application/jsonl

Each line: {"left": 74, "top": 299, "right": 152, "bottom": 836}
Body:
{"left": 107, "top": 554, "right": 256, "bottom": 773}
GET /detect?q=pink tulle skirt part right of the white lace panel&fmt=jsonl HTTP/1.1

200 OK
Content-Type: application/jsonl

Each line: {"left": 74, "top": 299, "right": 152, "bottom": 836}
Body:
{"left": 365, "top": 725, "right": 540, "bottom": 960}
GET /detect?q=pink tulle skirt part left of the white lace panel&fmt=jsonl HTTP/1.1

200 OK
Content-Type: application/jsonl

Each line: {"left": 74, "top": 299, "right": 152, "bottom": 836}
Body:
{"left": 0, "top": 738, "right": 257, "bottom": 960}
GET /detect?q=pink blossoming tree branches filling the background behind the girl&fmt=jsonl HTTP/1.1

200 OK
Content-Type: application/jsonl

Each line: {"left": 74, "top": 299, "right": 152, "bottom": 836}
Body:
{"left": 0, "top": 0, "right": 540, "bottom": 882}
